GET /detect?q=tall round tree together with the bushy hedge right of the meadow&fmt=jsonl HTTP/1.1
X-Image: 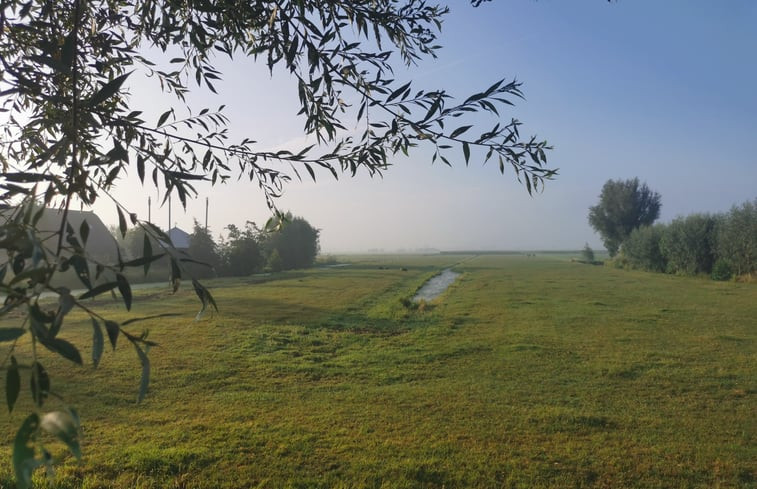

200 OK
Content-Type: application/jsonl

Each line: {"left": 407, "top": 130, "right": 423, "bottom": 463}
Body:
{"left": 589, "top": 178, "right": 757, "bottom": 279}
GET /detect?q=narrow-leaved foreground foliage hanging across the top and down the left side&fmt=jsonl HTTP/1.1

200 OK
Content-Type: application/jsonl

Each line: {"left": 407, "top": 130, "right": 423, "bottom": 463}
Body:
{"left": 0, "top": 0, "right": 556, "bottom": 487}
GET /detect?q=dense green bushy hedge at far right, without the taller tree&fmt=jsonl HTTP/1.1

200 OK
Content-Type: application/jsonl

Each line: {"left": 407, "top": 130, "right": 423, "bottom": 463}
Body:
{"left": 615, "top": 199, "right": 757, "bottom": 280}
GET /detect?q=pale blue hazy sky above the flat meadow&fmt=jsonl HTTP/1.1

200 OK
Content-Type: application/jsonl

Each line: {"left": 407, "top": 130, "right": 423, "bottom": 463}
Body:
{"left": 96, "top": 0, "right": 757, "bottom": 252}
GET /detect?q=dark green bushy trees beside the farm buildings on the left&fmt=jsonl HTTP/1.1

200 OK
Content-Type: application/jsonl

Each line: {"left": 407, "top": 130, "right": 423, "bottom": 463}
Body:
{"left": 120, "top": 213, "right": 320, "bottom": 278}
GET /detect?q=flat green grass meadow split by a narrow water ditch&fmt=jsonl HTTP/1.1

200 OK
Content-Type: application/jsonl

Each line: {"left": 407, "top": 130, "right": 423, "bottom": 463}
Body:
{"left": 0, "top": 255, "right": 757, "bottom": 489}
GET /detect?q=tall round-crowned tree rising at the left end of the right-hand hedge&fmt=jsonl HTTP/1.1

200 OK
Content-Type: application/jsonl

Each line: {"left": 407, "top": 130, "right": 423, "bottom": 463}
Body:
{"left": 589, "top": 178, "right": 661, "bottom": 256}
